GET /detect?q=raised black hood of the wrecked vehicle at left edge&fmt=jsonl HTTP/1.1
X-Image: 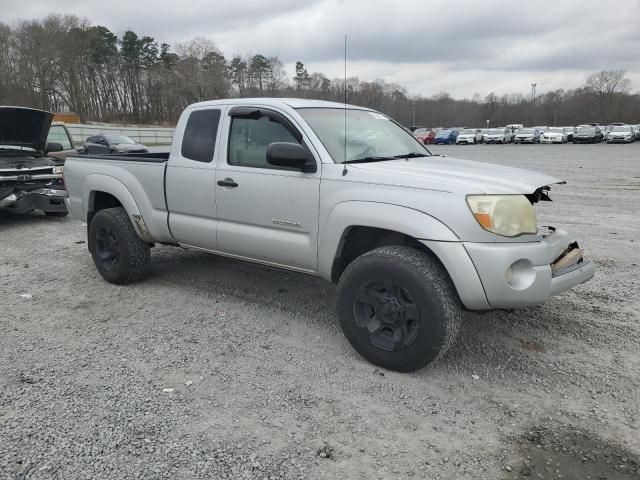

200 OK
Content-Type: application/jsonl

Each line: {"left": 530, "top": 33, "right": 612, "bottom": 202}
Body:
{"left": 0, "top": 106, "right": 53, "bottom": 152}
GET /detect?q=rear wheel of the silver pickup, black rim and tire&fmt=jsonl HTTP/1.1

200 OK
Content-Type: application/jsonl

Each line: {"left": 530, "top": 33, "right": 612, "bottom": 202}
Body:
{"left": 89, "top": 207, "right": 151, "bottom": 285}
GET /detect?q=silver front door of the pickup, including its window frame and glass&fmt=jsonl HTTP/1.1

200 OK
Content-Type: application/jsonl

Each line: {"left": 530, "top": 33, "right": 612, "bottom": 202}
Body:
{"left": 216, "top": 107, "right": 321, "bottom": 271}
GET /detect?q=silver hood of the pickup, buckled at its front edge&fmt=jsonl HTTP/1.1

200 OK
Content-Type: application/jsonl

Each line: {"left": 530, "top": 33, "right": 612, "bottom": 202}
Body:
{"left": 349, "top": 156, "right": 563, "bottom": 195}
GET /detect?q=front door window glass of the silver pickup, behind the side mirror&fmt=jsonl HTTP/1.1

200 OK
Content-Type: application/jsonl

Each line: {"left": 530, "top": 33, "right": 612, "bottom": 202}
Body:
{"left": 229, "top": 116, "right": 300, "bottom": 169}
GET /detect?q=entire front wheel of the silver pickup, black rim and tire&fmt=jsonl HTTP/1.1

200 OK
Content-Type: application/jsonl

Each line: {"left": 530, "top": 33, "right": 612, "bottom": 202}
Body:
{"left": 338, "top": 246, "right": 462, "bottom": 372}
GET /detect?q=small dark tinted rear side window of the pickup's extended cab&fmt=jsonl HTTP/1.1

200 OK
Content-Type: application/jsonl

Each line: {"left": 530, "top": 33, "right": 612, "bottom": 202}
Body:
{"left": 182, "top": 109, "right": 220, "bottom": 163}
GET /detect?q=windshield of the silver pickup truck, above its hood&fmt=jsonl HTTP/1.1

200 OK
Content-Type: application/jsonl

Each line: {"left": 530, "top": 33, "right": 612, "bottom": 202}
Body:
{"left": 298, "top": 108, "right": 430, "bottom": 163}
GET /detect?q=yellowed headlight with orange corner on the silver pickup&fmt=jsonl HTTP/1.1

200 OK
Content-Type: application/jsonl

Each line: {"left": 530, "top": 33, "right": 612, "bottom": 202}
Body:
{"left": 467, "top": 195, "right": 538, "bottom": 237}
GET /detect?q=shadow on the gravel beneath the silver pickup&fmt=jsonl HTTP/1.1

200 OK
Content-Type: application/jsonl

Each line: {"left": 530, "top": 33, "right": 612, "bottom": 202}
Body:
{"left": 152, "top": 247, "right": 608, "bottom": 382}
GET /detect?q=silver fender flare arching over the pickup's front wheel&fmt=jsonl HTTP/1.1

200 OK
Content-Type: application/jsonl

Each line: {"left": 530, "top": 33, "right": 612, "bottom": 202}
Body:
{"left": 318, "top": 201, "right": 460, "bottom": 280}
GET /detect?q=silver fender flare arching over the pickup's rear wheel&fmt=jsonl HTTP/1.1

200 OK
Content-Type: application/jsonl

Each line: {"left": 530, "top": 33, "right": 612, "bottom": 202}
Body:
{"left": 82, "top": 173, "right": 155, "bottom": 243}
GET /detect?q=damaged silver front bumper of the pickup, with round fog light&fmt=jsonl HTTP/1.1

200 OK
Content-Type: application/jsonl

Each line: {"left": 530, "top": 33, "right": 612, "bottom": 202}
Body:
{"left": 423, "top": 230, "right": 595, "bottom": 310}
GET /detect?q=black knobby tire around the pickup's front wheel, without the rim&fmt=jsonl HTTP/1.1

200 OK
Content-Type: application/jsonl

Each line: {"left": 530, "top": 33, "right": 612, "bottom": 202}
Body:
{"left": 337, "top": 246, "right": 462, "bottom": 372}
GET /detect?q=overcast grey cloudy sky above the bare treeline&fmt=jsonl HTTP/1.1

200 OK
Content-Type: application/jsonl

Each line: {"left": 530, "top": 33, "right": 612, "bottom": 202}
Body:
{"left": 0, "top": 0, "right": 640, "bottom": 97}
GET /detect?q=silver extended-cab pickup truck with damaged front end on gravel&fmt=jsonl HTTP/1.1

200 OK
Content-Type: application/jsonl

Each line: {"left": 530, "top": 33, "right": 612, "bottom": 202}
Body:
{"left": 64, "top": 98, "right": 594, "bottom": 371}
